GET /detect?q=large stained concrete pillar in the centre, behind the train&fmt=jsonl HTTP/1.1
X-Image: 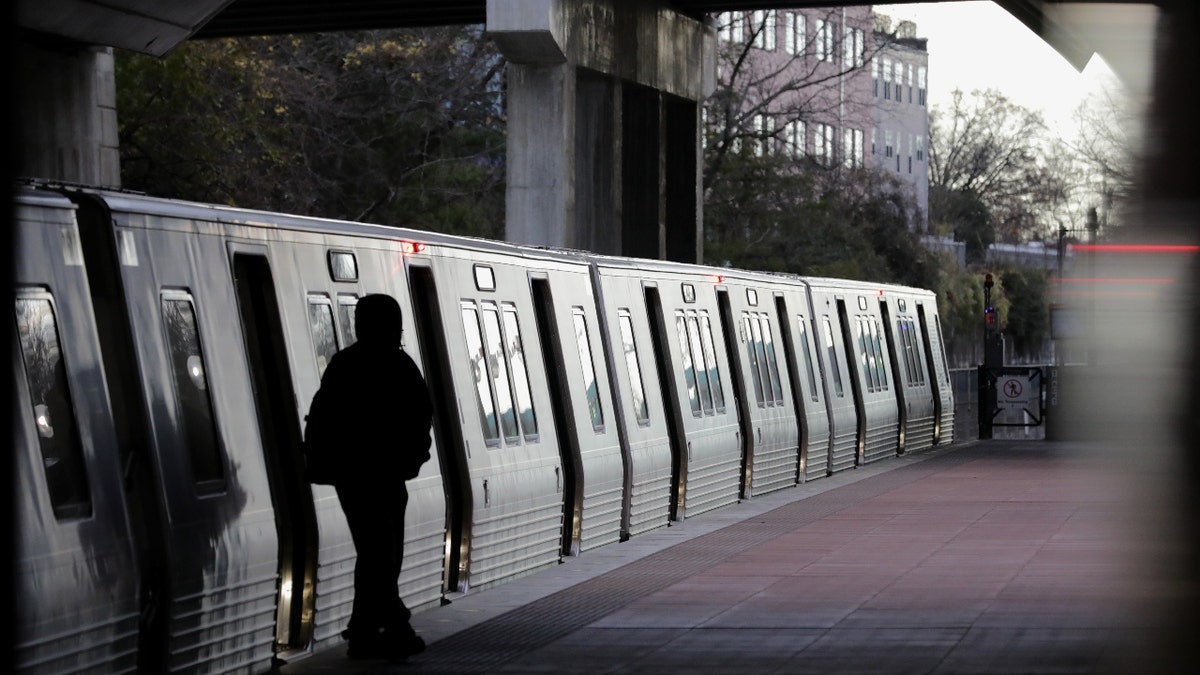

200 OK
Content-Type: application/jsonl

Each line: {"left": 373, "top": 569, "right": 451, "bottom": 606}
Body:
{"left": 487, "top": 0, "right": 715, "bottom": 262}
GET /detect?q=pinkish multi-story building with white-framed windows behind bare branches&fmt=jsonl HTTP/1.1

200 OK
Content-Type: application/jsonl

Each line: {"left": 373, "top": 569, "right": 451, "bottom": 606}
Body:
{"left": 714, "top": 5, "right": 929, "bottom": 232}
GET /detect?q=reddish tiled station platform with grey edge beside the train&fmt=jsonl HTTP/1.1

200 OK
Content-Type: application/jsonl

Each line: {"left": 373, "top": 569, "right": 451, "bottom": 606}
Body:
{"left": 280, "top": 440, "right": 1194, "bottom": 675}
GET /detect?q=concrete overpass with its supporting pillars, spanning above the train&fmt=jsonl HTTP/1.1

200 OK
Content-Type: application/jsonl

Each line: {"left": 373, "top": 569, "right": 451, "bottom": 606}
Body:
{"left": 14, "top": 0, "right": 1200, "bottom": 261}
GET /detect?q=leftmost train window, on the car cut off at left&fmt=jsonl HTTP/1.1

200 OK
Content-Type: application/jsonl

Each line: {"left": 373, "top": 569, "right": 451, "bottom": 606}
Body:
{"left": 16, "top": 291, "right": 91, "bottom": 519}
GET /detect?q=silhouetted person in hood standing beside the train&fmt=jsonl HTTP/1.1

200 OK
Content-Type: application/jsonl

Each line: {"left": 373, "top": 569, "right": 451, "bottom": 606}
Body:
{"left": 305, "top": 294, "right": 432, "bottom": 659}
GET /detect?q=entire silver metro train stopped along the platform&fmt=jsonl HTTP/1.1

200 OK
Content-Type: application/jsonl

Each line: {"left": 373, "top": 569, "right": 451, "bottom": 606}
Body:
{"left": 11, "top": 185, "right": 954, "bottom": 673}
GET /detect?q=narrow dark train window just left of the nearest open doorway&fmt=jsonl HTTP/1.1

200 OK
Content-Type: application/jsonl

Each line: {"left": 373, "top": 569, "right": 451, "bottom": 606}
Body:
{"left": 162, "top": 293, "right": 224, "bottom": 491}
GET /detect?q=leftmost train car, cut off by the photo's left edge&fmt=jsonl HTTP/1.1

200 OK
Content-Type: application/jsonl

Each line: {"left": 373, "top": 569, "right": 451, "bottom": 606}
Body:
{"left": 10, "top": 186, "right": 146, "bottom": 674}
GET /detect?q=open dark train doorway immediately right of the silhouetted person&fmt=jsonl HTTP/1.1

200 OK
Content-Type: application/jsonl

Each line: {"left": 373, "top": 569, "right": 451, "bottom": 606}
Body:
{"left": 408, "top": 264, "right": 474, "bottom": 591}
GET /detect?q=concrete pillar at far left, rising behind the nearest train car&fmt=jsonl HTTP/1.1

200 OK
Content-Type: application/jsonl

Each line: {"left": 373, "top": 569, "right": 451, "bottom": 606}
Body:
{"left": 13, "top": 40, "right": 121, "bottom": 187}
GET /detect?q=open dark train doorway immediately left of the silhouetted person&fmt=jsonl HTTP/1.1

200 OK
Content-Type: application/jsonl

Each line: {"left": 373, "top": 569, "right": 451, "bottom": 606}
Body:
{"left": 229, "top": 244, "right": 317, "bottom": 652}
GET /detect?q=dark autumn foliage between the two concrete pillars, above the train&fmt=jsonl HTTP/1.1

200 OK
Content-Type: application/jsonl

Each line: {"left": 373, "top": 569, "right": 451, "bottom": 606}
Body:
{"left": 118, "top": 26, "right": 505, "bottom": 237}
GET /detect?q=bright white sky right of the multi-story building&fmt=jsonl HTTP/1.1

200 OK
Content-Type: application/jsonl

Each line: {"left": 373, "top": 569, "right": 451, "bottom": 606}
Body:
{"left": 875, "top": 1, "right": 1147, "bottom": 132}
